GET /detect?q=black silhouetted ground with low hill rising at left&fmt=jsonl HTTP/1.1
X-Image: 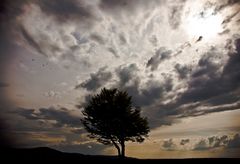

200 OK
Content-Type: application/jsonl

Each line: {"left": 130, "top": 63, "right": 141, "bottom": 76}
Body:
{"left": 0, "top": 147, "right": 240, "bottom": 164}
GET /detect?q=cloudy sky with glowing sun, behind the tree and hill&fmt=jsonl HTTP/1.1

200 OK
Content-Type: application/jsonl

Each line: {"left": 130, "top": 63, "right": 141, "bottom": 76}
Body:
{"left": 0, "top": 0, "right": 240, "bottom": 158}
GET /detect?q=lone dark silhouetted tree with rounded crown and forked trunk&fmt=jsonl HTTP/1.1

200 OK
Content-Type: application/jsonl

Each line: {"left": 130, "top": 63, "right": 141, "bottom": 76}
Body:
{"left": 82, "top": 88, "right": 149, "bottom": 157}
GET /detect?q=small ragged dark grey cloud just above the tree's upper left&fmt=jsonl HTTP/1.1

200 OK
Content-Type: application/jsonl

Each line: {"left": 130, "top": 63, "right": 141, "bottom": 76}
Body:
{"left": 75, "top": 67, "right": 112, "bottom": 91}
